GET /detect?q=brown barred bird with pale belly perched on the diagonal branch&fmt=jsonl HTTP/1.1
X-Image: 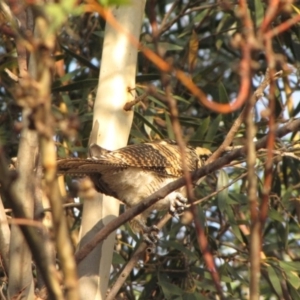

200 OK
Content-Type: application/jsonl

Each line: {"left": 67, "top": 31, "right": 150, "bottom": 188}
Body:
{"left": 57, "top": 140, "right": 211, "bottom": 241}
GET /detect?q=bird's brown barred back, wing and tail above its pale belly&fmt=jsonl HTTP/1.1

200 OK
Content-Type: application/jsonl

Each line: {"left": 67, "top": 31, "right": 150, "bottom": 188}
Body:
{"left": 57, "top": 140, "right": 211, "bottom": 177}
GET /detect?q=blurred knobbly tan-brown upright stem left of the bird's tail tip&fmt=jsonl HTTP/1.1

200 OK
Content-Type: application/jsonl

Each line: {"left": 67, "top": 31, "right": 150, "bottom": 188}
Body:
{"left": 34, "top": 16, "right": 79, "bottom": 300}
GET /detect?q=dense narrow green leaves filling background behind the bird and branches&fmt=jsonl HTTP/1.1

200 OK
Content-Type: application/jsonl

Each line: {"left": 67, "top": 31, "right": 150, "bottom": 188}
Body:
{"left": 0, "top": 0, "right": 300, "bottom": 300}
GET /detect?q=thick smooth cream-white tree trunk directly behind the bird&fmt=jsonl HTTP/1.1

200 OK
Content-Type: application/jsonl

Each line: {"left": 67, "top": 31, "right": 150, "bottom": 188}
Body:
{"left": 78, "top": 0, "right": 145, "bottom": 300}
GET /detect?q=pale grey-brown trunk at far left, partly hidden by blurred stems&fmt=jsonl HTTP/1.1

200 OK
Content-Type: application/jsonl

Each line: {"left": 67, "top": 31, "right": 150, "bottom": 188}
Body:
{"left": 8, "top": 3, "right": 38, "bottom": 299}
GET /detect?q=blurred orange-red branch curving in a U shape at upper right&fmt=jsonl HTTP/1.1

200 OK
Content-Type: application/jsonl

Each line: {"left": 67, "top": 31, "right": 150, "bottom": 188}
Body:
{"left": 85, "top": 0, "right": 299, "bottom": 113}
